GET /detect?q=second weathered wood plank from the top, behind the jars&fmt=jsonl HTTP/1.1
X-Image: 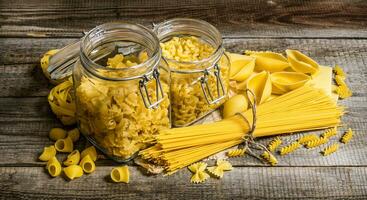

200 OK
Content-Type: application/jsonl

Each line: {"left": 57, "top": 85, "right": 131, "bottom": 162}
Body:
{"left": 0, "top": 38, "right": 367, "bottom": 97}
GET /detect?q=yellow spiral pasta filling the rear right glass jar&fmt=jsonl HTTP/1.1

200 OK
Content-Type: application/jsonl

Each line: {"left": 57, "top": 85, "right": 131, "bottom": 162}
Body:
{"left": 160, "top": 36, "right": 229, "bottom": 126}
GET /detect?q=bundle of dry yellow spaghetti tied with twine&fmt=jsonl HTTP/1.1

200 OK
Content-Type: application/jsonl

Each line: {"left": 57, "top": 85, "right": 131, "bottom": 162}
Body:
{"left": 140, "top": 86, "right": 344, "bottom": 174}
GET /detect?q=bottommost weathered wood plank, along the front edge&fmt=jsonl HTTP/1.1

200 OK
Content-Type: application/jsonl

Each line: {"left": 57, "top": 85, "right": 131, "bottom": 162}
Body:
{"left": 0, "top": 167, "right": 367, "bottom": 199}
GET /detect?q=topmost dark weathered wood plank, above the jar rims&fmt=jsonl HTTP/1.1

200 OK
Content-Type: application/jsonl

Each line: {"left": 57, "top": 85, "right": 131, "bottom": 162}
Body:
{"left": 0, "top": 0, "right": 367, "bottom": 38}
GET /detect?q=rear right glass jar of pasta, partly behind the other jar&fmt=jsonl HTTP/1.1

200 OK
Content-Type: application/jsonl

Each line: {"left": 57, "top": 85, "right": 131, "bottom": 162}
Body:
{"left": 154, "top": 18, "right": 230, "bottom": 127}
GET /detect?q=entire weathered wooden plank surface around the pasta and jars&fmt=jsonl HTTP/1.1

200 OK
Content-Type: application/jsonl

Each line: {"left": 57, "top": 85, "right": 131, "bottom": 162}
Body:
{"left": 0, "top": 0, "right": 367, "bottom": 199}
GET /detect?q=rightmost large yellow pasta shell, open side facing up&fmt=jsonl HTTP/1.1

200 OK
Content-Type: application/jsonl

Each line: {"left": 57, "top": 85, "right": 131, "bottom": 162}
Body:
{"left": 285, "top": 49, "right": 319, "bottom": 74}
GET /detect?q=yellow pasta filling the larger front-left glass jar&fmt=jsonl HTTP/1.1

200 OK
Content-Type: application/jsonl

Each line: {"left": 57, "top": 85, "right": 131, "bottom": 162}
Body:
{"left": 76, "top": 53, "right": 170, "bottom": 158}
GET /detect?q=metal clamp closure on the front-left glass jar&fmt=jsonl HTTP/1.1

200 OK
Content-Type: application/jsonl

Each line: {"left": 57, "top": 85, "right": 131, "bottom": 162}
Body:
{"left": 139, "top": 69, "right": 164, "bottom": 109}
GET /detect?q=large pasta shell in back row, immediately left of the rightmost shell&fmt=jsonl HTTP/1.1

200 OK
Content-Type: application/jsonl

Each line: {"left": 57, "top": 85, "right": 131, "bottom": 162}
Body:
{"left": 245, "top": 51, "right": 289, "bottom": 72}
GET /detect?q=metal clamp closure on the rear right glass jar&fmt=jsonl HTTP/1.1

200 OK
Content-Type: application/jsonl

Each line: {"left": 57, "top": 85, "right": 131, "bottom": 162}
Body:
{"left": 200, "top": 63, "right": 226, "bottom": 104}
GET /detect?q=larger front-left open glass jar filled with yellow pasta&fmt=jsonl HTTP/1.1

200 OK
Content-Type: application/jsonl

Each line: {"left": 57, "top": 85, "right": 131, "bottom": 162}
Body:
{"left": 73, "top": 23, "right": 170, "bottom": 162}
